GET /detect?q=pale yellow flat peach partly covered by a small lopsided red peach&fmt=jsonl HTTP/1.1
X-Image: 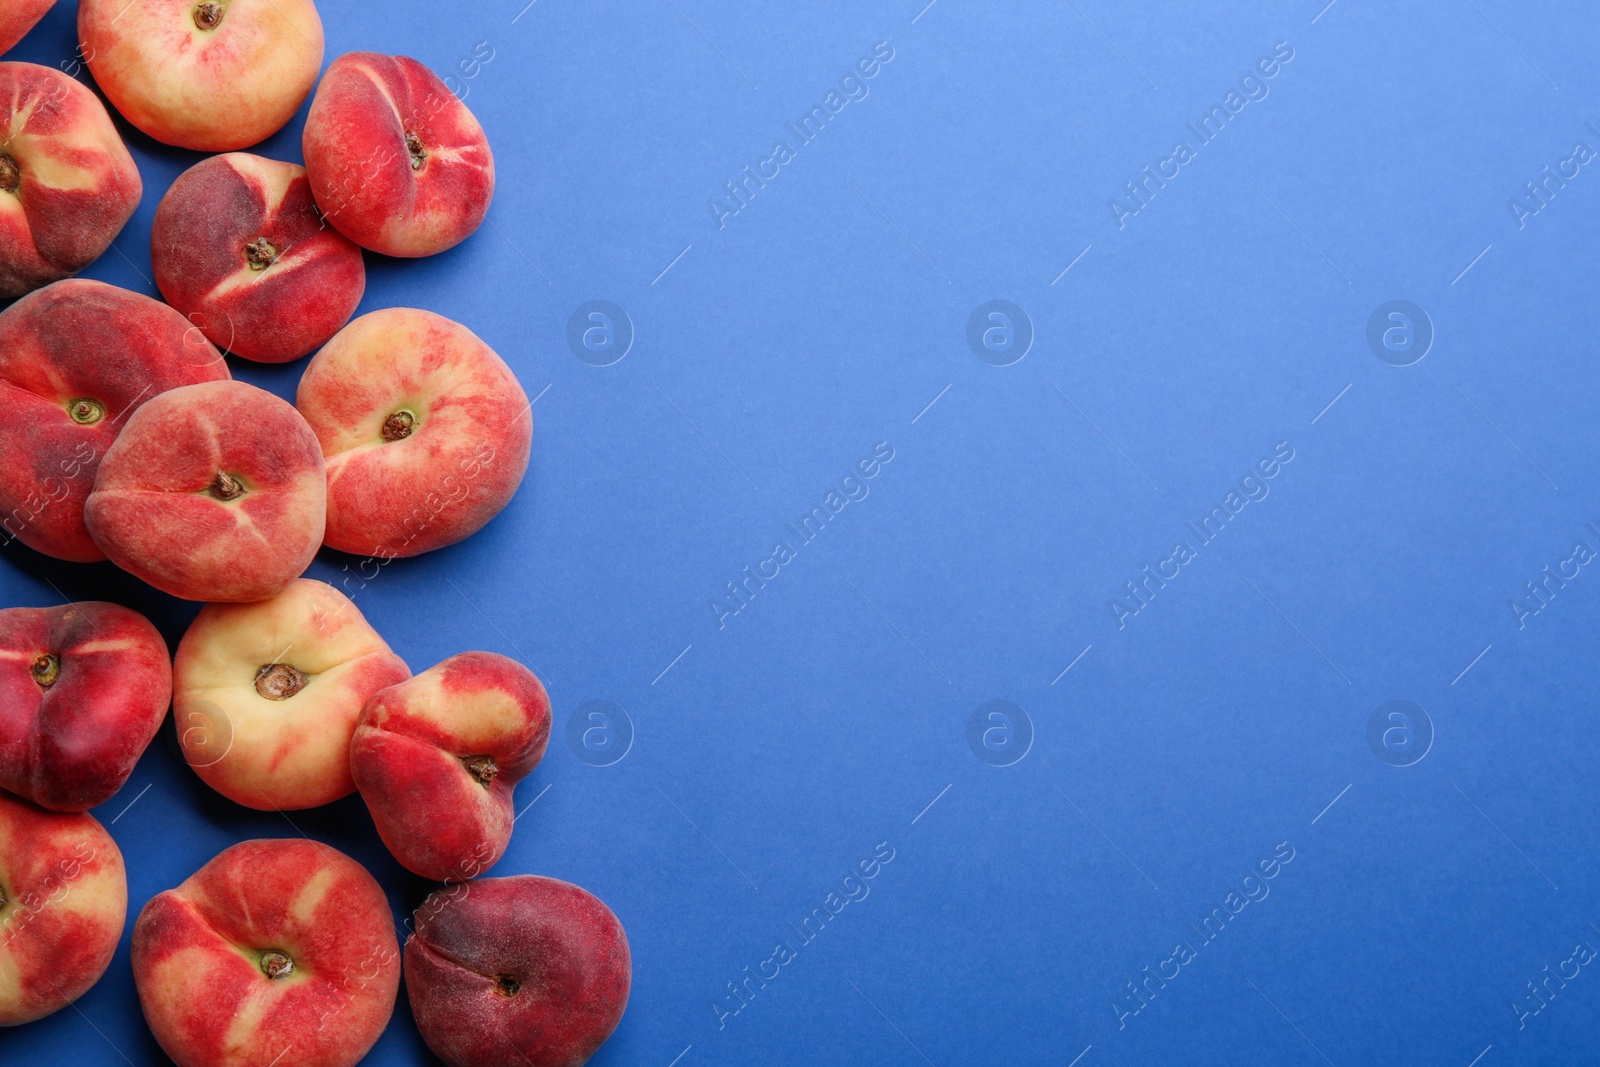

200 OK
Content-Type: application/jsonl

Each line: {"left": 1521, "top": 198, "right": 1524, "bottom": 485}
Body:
{"left": 173, "top": 577, "right": 411, "bottom": 811}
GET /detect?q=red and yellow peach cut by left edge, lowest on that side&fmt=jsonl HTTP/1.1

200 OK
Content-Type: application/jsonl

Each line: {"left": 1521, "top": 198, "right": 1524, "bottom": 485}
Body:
{"left": 0, "top": 793, "right": 128, "bottom": 1027}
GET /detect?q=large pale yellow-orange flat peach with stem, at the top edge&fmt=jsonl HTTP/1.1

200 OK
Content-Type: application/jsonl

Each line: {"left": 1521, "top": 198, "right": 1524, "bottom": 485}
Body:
{"left": 78, "top": 0, "right": 323, "bottom": 152}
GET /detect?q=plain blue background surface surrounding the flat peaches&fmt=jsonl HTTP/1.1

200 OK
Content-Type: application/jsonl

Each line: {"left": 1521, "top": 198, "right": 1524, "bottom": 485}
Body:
{"left": 0, "top": 0, "right": 1600, "bottom": 1067}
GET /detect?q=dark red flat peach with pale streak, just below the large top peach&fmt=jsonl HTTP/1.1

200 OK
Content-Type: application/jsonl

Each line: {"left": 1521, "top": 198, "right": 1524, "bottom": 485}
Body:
{"left": 150, "top": 152, "right": 366, "bottom": 363}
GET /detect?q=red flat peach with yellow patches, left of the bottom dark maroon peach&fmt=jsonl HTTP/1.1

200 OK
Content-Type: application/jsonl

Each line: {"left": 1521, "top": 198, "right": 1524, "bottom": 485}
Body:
{"left": 133, "top": 838, "right": 400, "bottom": 1067}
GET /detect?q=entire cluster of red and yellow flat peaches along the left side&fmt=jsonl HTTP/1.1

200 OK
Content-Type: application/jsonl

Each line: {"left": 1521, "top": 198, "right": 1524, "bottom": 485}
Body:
{"left": 0, "top": 0, "right": 630, "bottom": 1067}
